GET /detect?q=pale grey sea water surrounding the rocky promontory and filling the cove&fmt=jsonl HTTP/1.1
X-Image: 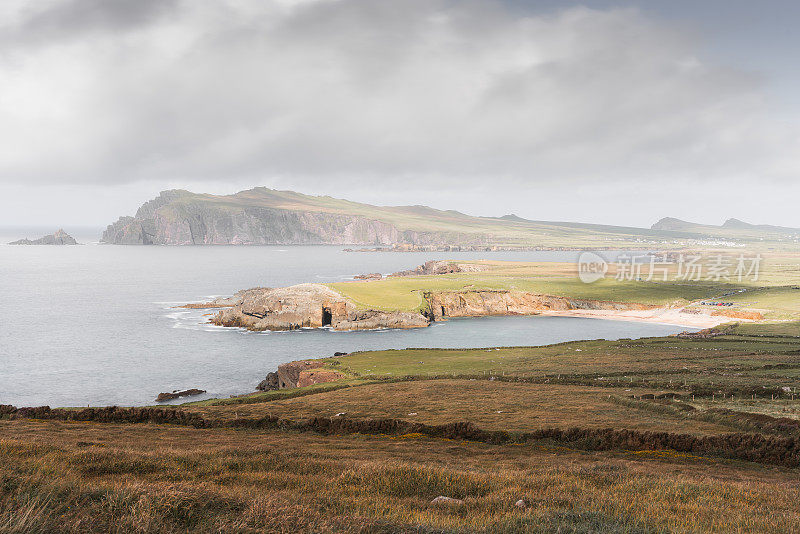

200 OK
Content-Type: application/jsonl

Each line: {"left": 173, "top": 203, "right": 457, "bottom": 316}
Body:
{"left": 0, "top": 236, "right": 685, "bottom": 406}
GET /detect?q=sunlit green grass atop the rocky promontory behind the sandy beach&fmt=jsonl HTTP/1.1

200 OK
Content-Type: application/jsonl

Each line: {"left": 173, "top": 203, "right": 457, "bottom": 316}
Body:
{"left": 329, "top": 255, "right": 800, "bottom": 319}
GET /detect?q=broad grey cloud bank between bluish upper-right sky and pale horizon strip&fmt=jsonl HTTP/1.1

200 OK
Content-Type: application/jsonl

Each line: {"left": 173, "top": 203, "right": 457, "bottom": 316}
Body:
{"left": 0, "top": 0, "right": 797, "bottom": 191}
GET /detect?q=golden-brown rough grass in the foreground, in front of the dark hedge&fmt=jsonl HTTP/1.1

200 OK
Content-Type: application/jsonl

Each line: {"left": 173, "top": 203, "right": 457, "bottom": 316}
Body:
{"left": 0, "top": 420, "right": 800, "bottom": 532}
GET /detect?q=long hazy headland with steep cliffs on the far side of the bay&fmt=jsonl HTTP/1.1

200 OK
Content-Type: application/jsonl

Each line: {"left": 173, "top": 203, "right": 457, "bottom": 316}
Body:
{"left": 102, "top": 187, "right": 796, "bottom": 249}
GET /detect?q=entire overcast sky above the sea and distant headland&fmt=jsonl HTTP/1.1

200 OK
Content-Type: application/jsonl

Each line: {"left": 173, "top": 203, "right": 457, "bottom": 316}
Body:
{"left": 0, "top": 0, "right": 800, "bottom": 227}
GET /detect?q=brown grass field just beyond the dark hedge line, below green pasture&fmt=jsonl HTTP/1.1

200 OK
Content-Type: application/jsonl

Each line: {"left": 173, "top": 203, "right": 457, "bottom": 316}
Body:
{"left": 186, "top": 380, "right": 731, "bottom": 434}
